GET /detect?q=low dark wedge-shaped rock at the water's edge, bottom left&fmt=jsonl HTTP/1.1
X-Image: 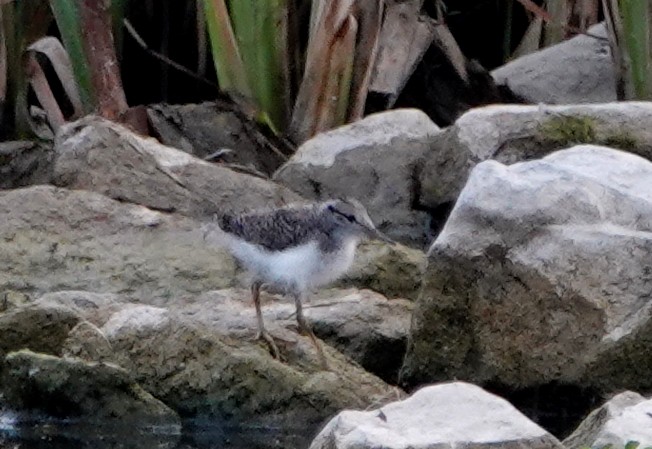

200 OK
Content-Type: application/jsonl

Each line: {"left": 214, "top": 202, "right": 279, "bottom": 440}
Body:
{"left": 2, "top": 350, "right": 180, "bottom": 428}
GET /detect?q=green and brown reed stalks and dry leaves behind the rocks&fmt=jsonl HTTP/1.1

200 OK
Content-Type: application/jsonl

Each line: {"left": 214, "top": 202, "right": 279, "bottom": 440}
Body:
{"left": 0, "top": 0, "right": 651, "bottom": 142}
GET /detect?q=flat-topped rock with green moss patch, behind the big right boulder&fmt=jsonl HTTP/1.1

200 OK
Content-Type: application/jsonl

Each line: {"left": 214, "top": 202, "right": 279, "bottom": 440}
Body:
{"left": 418, "top": 102, "right": 652, "bottom": 210}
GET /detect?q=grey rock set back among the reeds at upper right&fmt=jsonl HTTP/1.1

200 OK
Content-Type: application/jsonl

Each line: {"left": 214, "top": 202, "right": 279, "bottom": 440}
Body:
{"left": 491, "top": 23, "right": 618, "bottom": 104}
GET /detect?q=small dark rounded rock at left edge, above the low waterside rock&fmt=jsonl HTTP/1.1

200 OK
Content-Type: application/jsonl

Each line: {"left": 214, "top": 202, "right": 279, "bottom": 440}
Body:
{"left": 0, "top": 302, "right": 81, "bottom": 364}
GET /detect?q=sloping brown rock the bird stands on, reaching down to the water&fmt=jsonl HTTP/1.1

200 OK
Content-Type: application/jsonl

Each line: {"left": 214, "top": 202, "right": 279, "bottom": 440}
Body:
{"left": 54, "top": 290, "right": 402, "bottom": 431}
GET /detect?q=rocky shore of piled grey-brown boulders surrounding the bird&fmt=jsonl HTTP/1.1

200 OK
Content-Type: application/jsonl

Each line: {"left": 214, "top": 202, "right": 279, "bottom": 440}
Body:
{"left": 0, "top": 26, "right": 652, "bottom": 449}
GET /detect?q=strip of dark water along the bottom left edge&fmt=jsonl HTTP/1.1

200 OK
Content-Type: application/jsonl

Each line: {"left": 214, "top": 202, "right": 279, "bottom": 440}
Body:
{"left": 0, "top": 424, "right": 314, "bottom": 449}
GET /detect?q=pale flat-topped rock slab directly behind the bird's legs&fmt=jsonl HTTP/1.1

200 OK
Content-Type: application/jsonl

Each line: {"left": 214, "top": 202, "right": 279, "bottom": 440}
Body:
{"left": 196, "top": 289, "right": 413, "bottom": 384}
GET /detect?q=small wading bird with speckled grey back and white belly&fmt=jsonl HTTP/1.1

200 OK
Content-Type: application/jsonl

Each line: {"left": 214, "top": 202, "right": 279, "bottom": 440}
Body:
{"left": 204, "top": 198, "right": 395, "bottom": 369}
